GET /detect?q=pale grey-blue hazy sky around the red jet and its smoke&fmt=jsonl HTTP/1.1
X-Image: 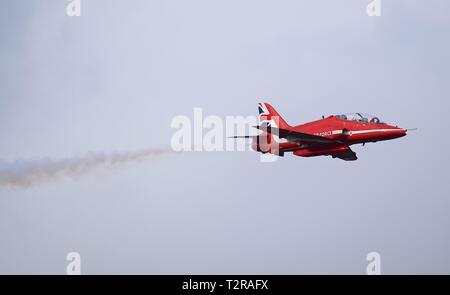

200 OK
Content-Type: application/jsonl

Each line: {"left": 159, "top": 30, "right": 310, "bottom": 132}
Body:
{"left": 0, "top": 0, "right": 450, "bottom": 274}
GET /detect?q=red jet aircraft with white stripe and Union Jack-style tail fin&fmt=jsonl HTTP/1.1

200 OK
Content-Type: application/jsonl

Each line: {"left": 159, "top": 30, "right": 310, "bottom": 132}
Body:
{"left": 233, "top": 103, "right": 414, "bottom": 161}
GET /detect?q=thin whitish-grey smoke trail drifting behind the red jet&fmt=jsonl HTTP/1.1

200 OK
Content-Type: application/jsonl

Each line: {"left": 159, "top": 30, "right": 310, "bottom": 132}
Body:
{"left": 0, "top": 149, "right": 172, "bottom": 188}
